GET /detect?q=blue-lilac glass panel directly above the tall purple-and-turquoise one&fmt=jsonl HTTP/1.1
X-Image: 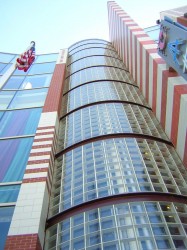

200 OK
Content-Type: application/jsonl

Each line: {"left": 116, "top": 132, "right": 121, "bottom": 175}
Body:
{"left": 0, "top": 108, "right": 42, "bottom": 137}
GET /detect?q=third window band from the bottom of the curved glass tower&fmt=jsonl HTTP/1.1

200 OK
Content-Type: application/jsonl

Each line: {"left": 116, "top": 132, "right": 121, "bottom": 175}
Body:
{"left": 59, "top": 103, "right": 167, "bottom": 149}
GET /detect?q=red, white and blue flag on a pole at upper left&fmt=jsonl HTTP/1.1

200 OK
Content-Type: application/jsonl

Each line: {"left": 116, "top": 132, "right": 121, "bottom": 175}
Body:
{"left": 16, "top": 41, "right": 35, "bottom": 72}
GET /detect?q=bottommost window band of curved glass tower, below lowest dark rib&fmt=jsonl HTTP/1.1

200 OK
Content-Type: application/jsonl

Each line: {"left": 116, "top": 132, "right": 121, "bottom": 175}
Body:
{"left": 45, "top": 202, "right": 187, "bottom": 250}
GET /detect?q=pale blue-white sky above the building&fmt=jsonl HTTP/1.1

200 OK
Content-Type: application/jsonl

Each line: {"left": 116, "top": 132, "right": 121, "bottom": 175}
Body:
{"left": 0, "top": 0, "right": 187, "bottom": 54}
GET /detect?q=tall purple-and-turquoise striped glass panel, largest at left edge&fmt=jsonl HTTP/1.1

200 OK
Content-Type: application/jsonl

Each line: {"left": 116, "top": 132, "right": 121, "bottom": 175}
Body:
{"left": 0, "top": 137, "right": 33, "bottom": 182}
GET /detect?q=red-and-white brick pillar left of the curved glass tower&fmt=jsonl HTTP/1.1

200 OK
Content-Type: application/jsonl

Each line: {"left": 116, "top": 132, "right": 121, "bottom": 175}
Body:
{"left": 5, "top": 50, "right": 67, "bottom": 250}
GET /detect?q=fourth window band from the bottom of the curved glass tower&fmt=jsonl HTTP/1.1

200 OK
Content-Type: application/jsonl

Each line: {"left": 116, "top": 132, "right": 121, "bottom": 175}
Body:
{"left": 62, "top": 81, "right": 147, "bottom": 114}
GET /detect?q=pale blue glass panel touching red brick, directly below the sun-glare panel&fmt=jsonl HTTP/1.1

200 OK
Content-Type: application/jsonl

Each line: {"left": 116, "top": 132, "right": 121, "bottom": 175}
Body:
{"left": 8, "top": 89, "right": 48, "bottom": 109}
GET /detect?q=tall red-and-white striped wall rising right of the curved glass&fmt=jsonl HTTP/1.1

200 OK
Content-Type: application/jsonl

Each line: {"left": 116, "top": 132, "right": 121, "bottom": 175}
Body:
{"left": 108, "top": 1, "right": 187, "bottom": 167}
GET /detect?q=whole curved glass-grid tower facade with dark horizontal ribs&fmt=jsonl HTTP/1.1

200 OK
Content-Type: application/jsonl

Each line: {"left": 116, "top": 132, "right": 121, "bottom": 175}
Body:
{"left": 45, "top": 39, "right": 187, "bottom": 250}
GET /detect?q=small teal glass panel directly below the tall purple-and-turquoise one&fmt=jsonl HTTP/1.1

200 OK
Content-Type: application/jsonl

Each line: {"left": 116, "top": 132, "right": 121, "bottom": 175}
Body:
{"left": 0, "top": 185, "right": 20, "bottom": 203}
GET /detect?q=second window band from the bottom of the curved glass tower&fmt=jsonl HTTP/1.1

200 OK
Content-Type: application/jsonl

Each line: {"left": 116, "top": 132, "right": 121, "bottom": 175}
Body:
{"left": 50, "top": 138, "right": 187, "bottom": 216}
